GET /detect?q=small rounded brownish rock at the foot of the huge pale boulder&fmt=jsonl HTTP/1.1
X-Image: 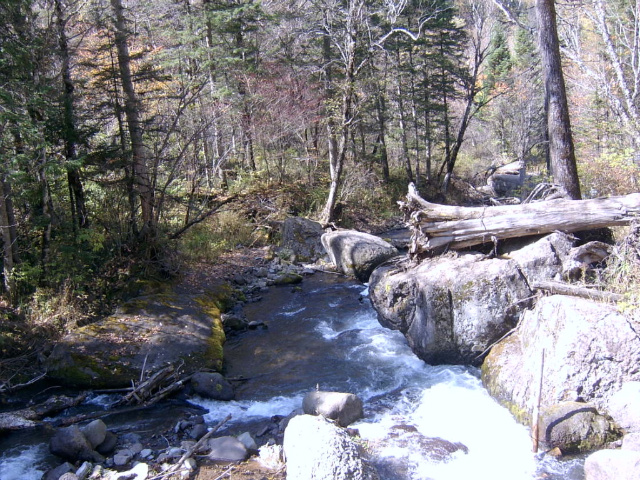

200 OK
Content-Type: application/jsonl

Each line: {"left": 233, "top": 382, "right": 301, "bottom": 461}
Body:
{"left": 539, "top": 402, "right": 620, "bottom": 454}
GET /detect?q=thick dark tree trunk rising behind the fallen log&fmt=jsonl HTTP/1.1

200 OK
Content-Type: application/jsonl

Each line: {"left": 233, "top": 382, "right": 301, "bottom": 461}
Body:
{"left": 536, "top": 0, "right": 582, "bottom": 200}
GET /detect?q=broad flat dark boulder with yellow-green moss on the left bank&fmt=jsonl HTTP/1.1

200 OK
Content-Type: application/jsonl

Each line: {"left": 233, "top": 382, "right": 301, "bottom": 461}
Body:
{"left": 46, "top": 288, "right": 228, "bottom": 388}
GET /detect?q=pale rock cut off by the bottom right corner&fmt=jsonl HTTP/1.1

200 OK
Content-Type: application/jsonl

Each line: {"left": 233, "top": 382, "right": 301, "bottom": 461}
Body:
{"left": 584, "top": 450, "right": 640, "bottom": 480}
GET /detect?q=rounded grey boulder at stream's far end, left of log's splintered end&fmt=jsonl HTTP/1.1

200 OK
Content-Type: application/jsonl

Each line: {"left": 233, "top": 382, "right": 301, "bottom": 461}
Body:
{"left": 321, "top": 230, "right": 398, "bottom": 282}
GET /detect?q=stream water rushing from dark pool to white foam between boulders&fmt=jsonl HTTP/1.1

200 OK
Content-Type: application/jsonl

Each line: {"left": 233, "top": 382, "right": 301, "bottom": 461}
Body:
{"left": 190, "top": 274, "right": 583, "bottom": 480}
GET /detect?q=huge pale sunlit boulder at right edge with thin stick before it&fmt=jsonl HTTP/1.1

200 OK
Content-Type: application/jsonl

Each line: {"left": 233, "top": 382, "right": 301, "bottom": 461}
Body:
{"left": 482, "top": 295, "right": 640, "bottom": 424}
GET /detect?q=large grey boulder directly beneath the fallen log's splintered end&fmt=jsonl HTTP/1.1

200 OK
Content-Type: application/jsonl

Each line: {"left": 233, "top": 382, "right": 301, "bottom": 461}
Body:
{"left": 369, "top": 254, "right": 532, "bottom": 364}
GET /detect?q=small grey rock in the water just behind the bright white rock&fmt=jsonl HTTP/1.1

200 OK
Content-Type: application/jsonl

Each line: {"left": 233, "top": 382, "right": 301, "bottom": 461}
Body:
{"left": 302, "top": 392, "right": 363, "bottom": 427}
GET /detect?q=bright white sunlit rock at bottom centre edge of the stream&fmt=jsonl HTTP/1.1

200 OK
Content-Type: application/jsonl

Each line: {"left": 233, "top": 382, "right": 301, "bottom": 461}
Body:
{"left": 283, "top": 415, "right": 378, "bottom": 480}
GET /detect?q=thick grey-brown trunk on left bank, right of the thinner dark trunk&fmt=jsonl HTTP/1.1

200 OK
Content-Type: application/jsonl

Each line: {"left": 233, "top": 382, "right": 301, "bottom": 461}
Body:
{"left": 111, "top": 0, "right": 155, "bottom": 240}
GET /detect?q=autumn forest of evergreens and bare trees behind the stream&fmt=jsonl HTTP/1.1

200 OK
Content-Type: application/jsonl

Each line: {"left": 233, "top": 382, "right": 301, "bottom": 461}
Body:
{"left": 0, "top": 0, "right": 640, "bottom": 355}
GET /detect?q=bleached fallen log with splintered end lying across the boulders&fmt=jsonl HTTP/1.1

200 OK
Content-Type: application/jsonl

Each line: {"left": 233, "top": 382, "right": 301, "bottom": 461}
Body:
{"left": 401, "top": 184, "right": 640, "bottom": 254}
